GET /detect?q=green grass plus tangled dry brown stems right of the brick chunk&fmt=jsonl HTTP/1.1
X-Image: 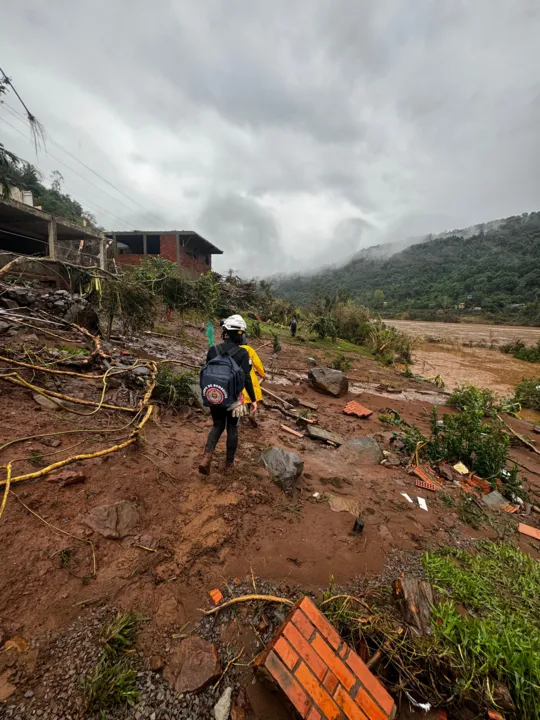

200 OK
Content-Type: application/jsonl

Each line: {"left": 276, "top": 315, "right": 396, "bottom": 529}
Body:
{"left": 321, "top": 541, "right": 540, "bottom": 720}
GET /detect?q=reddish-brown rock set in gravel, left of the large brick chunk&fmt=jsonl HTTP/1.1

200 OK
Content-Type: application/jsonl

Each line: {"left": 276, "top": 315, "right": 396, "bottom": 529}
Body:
{"left": 164, "top": 635, "right": 221, "bottom": 693}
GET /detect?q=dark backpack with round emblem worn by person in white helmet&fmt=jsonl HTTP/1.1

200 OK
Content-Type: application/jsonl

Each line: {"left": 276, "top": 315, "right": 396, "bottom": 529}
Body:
{"left": 200, "top": 345, "right": 246, "bottom": 408}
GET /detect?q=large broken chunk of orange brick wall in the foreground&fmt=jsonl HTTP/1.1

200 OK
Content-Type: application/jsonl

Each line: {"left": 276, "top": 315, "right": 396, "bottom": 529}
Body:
{"left": 255, "top": 597, "right": 396, "bottom": 720}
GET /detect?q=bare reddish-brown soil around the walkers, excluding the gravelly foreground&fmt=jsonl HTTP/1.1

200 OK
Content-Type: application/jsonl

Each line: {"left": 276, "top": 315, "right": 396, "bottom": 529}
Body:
{"left": 0, "top": 331, "right": 540, "bottom": 718}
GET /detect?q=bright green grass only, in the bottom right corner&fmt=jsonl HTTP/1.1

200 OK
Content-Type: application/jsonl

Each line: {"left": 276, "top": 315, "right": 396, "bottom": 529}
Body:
{"left": 424, "top": 542, "right": 540, "bottom": 719}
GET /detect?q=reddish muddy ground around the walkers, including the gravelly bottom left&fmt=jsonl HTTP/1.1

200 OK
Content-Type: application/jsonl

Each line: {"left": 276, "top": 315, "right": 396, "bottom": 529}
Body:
{"left": 0, "top": 328, "right": 540, "bottom": 720}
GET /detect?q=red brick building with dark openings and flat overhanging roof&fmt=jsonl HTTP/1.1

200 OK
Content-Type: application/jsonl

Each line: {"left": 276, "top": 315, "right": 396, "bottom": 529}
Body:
{"left": 106, "top": 230, "right": 223, "bottom": 279}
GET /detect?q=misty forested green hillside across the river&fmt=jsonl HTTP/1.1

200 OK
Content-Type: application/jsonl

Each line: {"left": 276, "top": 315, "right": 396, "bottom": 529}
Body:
{"left": 274, "top": 213, "right": 540, "bottom": 324}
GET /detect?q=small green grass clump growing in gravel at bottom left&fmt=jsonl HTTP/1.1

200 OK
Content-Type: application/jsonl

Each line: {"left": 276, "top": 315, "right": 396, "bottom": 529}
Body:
{"left": 83, "top": 613, "right": 141, "bottom": 717}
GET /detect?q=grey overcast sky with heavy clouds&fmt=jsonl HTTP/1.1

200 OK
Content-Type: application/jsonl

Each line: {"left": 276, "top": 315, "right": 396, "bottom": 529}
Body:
{"left": 0, "top": 0, "right": 540, "bottom": 276}
